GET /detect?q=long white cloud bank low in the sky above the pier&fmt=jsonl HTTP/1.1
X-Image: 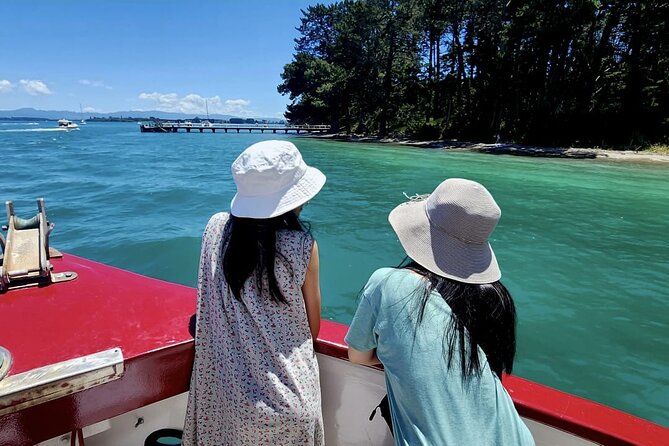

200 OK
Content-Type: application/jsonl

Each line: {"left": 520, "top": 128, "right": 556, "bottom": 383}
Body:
{"left": 139, "top": 92, "right": 254, "bottom": 117}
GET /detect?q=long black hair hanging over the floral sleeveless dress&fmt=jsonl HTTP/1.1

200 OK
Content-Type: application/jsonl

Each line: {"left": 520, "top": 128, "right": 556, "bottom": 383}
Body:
{"left": 221, "top": 211, "right": 309, "bottom": 303}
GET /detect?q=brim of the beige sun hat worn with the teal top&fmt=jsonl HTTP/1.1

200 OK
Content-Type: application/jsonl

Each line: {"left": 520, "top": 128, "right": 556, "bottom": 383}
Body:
{"left": 388, "top": 200, "right": 502, "bottom": 284}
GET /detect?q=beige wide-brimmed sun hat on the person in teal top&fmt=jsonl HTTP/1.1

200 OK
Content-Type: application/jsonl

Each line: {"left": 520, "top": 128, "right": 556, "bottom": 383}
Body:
{"left": 388, "top": 178, "right": 502, "bottom": 284}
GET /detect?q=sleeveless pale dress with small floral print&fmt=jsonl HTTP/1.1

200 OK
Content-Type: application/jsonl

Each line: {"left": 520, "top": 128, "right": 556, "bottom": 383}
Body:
{"left": 183, "top": 213, "right": 324, "bottom": 446}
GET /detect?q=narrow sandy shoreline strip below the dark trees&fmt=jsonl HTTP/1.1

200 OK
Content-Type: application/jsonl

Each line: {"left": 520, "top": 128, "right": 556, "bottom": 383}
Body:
{"left": 309, "top": 134, "right": 669, "bottom": 165}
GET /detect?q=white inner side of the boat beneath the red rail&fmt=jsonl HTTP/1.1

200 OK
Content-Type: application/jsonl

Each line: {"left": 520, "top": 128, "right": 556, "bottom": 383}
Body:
{"left": 38, "top": 354, "right": 596, "bottom": 446}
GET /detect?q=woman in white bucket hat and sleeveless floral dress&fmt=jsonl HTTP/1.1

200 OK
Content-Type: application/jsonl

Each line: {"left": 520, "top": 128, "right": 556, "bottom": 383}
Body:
{"left": 183, "top": 141, "right": 325, "bottom": 446}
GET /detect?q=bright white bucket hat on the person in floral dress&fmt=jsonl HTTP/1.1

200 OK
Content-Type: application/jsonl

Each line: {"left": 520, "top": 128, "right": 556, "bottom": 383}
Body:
{"left": 230, "top": 140, "right": 325, "bottom": 218}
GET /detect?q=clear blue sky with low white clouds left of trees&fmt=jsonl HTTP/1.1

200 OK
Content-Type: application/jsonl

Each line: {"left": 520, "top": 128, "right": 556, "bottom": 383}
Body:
{"left": 0, "top": 0, "right": 322, "bottom": 117}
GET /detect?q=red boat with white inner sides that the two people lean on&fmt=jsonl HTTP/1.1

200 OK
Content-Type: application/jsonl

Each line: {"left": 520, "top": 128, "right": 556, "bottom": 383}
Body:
{"left": 0, "top": 201, "right": 669, "bottom": 446}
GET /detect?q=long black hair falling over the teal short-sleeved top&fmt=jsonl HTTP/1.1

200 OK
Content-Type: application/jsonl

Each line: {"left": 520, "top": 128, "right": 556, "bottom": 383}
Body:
{"left": 400, "top": 258, "right": 516, "bottom": 380}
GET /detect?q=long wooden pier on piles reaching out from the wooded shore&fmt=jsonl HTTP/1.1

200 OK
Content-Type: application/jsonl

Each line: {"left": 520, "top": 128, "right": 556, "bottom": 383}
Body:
{"left": 139, "top": 121, "right": 330, "bottom": 135}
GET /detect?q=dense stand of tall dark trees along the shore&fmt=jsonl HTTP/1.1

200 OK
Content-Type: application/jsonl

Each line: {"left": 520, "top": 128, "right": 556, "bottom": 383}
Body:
{"left": 278, "top": 0, "right": 669, "bottom": 146}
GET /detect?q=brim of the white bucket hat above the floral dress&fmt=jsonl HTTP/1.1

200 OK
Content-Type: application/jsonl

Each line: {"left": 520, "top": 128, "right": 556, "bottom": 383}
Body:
{"left": 230, "top": 166, "right": 325, "bottom": 218}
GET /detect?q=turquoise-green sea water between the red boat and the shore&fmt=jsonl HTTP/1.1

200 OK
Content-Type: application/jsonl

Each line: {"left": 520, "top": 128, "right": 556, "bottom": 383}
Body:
{"left": 0, "top": 123, "right": 669, "bottom": 426}
